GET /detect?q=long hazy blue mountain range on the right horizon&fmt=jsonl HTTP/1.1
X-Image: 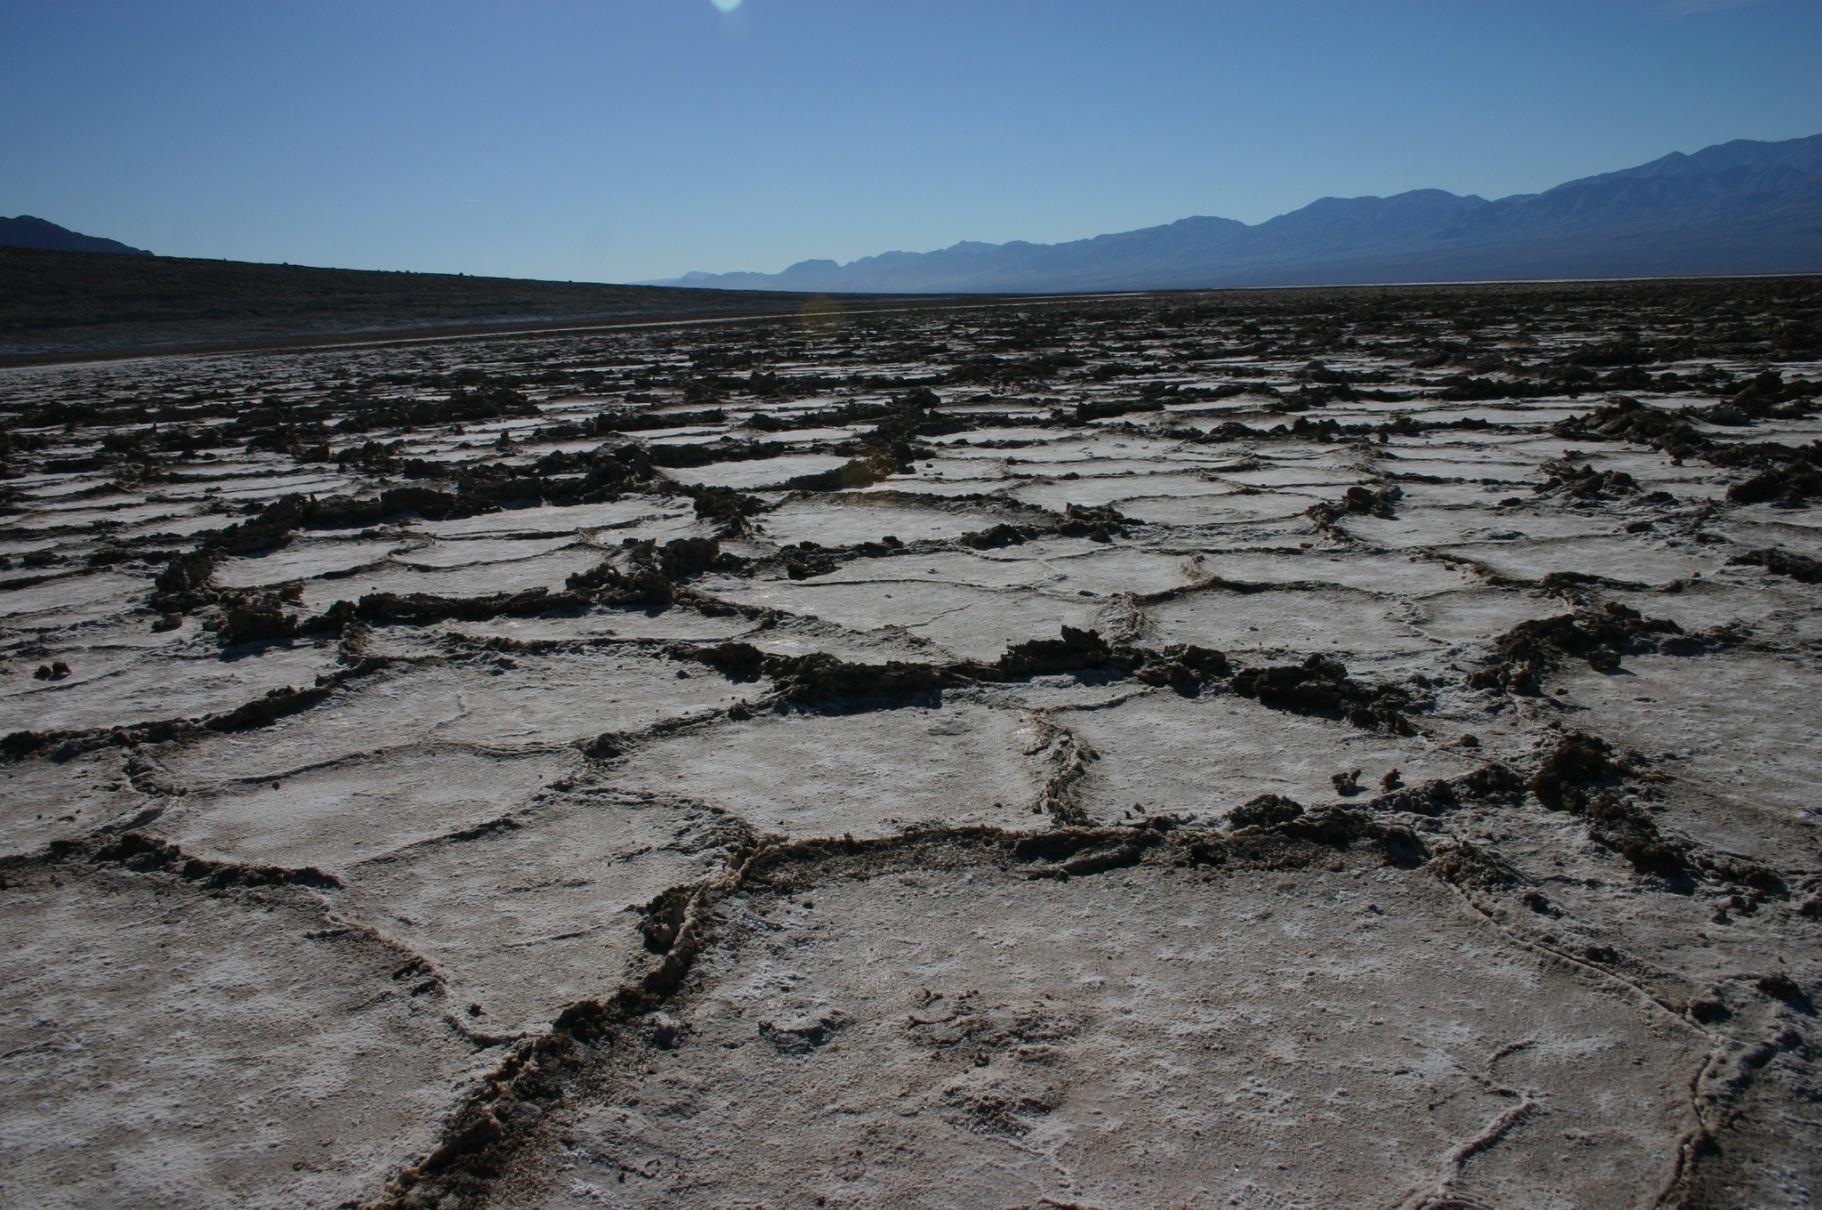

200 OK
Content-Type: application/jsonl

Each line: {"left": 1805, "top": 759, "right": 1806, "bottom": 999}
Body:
{"left": 650, "top": 135, "right": 1822, "bottom": 293}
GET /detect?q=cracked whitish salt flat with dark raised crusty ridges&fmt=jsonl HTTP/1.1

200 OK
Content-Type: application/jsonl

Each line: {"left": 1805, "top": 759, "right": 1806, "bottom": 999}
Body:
{"left": 0, "top": 281, "right": 1822, "bottom": 1208}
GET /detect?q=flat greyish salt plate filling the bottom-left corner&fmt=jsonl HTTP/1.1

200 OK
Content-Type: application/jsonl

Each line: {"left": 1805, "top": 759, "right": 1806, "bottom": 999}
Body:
{"left": 0, "top": 867, "right": 485, "bottom": 1210}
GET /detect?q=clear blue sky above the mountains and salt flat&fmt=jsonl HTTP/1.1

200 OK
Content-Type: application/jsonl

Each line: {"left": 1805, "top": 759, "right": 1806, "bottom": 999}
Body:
{"left": 0, "top": 0, "right": 1822, "bottom": 281}
